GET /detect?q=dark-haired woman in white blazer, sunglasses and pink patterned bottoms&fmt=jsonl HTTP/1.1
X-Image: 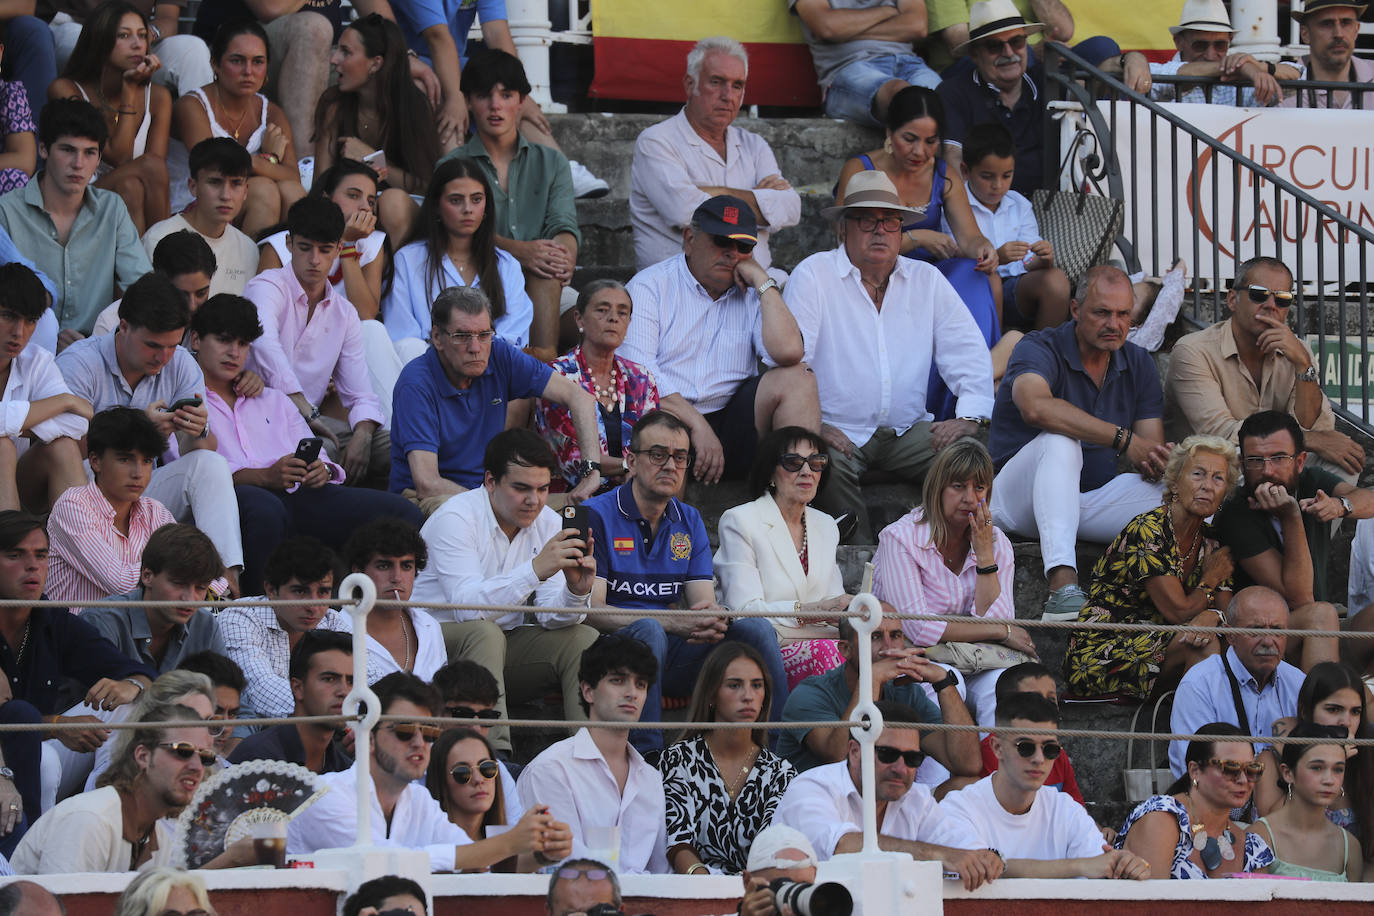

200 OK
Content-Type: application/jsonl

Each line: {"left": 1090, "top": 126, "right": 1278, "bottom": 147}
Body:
{"left": 714, "top": 426, "right": 851, "bottom": 688}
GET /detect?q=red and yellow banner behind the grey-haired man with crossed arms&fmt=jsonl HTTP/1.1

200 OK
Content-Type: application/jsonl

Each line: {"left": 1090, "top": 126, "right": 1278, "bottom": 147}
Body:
{"left": 591, "top": 0, "right": 820, "bottom": 107}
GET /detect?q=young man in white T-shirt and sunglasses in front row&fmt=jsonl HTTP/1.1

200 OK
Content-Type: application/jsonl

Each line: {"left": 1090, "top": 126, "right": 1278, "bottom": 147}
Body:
{"left": 940, "top": 694, "right": 1150, "bottom": 880}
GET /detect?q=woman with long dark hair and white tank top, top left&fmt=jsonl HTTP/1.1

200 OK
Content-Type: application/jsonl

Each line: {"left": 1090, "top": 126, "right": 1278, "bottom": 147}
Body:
{"left": 48, "top": 0, "right": 172, "bottom": 233}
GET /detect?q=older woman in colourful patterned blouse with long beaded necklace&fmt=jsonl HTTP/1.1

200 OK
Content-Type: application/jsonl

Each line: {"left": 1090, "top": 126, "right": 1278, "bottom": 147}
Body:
{"left": 534, "top": 279, "right": 658, "bottom": 493}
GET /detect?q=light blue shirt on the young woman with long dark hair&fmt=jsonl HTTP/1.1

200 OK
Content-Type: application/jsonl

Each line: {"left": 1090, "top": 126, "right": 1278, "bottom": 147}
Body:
{"left": 382, "top": 242, "right": 534, "bottom": 350}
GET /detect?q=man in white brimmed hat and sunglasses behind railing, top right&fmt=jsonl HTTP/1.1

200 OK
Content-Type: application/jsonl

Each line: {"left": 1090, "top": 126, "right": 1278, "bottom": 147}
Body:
{"left": 1137, "top": 0, "right": 1298, "bottom": 107}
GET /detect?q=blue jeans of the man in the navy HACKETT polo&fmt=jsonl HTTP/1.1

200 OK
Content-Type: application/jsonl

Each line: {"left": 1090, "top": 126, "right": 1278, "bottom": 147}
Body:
{"left": 618, "top": 617, "right": 787, "bottom": 754}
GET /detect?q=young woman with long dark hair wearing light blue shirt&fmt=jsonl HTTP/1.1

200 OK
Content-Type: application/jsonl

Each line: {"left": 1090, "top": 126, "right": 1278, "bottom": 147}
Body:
{"left": 382, "top": 157, "right": 534, "bottom": 360}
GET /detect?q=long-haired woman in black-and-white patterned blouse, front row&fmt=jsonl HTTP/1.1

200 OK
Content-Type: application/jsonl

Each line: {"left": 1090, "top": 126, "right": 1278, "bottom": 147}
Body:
{"left": 658, "top": 643, "right": 797, "bottom": 875}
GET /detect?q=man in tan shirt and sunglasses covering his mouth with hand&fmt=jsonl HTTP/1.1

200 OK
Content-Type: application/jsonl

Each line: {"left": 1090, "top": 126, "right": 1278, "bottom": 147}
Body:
{"left": 1164, "top": 255, "right": 1364, "bottom": 485}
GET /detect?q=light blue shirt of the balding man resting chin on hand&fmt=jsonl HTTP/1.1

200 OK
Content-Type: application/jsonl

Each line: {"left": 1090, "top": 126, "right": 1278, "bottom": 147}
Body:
{"left": 1169, "top": 648, "right": 1305, "bottom": 776}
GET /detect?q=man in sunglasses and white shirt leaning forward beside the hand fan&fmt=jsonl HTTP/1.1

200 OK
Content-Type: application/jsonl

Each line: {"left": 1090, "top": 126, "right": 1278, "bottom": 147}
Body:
{"left": 286, "top": 672, "right": 572, "bottom": 872}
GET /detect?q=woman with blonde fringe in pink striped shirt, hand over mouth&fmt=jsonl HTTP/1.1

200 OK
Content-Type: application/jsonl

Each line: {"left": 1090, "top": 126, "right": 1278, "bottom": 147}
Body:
{"left": 872, "top": 438, "right": 1036, "bottom": 725}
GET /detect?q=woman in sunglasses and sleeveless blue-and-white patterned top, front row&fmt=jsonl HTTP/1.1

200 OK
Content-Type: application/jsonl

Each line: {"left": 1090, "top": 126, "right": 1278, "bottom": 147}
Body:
{"left": 1116, "top": 722, "right": 1274, "bottom": 879}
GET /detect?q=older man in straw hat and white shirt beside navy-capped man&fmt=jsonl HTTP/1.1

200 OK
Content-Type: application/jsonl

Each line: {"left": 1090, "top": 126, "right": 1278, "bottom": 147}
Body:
{"left": 785, "top": 170, "right": 992, "bottom": 544}
